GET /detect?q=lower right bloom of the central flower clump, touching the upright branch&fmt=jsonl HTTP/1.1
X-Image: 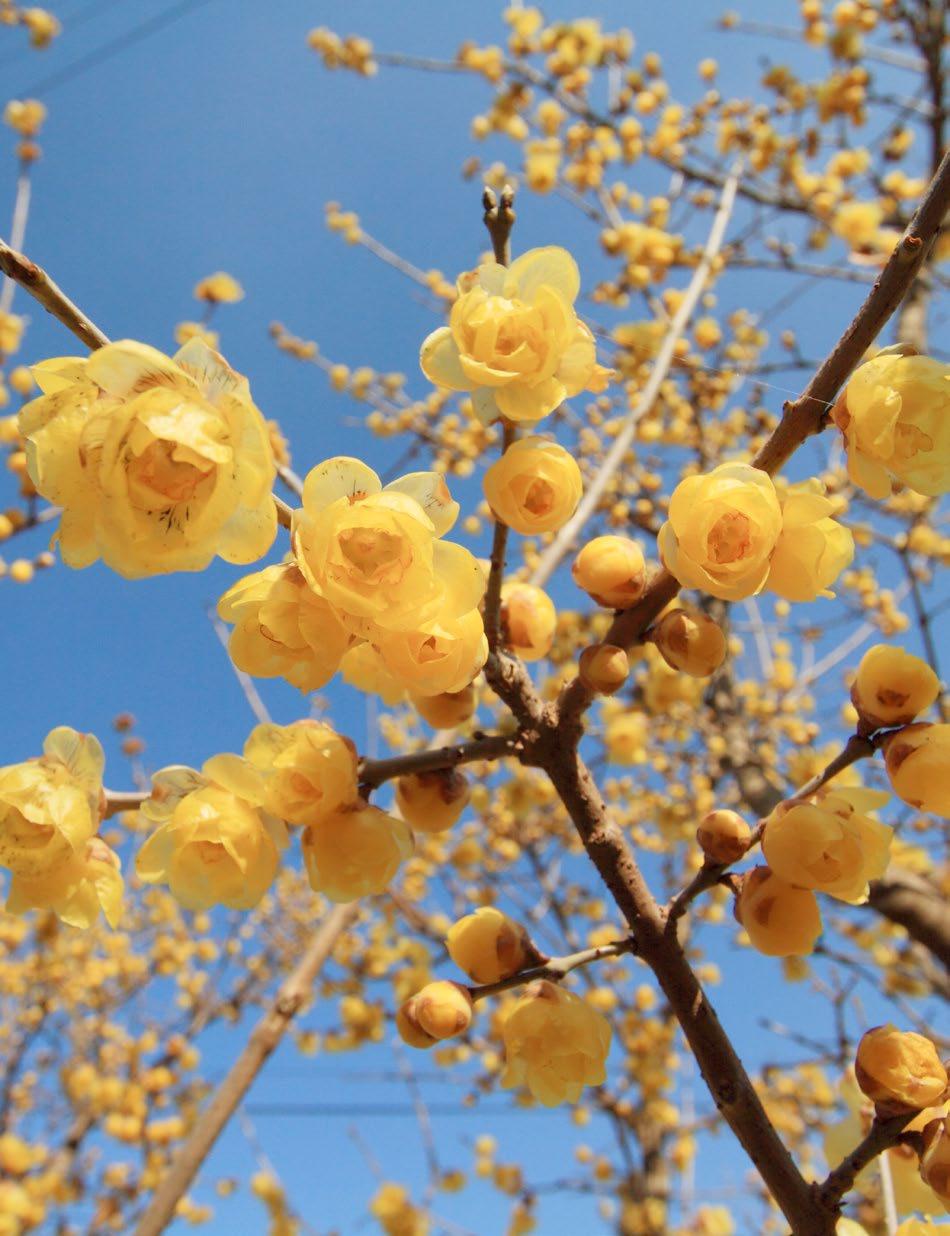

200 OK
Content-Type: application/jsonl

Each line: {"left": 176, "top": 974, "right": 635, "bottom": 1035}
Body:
{"left": 374, "top": 609, "right": 488, "bottom": 696}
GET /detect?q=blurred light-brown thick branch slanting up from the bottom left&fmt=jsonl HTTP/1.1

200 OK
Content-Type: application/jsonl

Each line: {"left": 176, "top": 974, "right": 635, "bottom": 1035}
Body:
{"left": 136, "top": 905, "right": 357, "bottom": 1236}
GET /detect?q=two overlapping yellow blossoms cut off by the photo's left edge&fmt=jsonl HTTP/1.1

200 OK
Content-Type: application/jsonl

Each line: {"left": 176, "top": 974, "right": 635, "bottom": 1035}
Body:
{"left": 0, "top": 726, "right": 122, "bottom": 927}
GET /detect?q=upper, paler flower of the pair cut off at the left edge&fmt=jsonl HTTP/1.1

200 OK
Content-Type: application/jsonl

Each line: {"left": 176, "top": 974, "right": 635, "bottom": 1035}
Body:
{"left": 0, "top": 726, "right": 105, "bottom": 879}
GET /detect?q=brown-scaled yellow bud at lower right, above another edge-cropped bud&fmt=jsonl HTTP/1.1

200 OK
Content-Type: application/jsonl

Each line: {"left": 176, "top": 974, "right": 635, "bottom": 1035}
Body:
{"left": 855, "top": 1025, "right": 948, "bottom": 1116}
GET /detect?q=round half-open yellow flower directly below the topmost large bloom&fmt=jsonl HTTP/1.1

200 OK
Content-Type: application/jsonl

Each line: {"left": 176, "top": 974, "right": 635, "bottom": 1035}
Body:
{"left": 483, "top": 436, "right": 583, "bottom": 536}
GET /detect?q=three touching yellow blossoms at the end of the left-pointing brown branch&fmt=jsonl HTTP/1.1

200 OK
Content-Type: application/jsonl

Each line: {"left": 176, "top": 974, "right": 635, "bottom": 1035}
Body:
{"left": 136, "top": 721, "right": 413, "bottom": 910}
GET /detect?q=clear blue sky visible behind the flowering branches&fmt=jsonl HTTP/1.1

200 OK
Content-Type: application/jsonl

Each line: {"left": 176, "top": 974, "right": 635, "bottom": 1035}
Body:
{"left": 0, "top": 0, "right": 938, "bottom": 1236}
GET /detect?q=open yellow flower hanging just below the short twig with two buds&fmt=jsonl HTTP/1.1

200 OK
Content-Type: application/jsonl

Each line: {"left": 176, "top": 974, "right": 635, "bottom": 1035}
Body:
{"left": 502, "top": 979, "right": 610, "bottom": 1107}
